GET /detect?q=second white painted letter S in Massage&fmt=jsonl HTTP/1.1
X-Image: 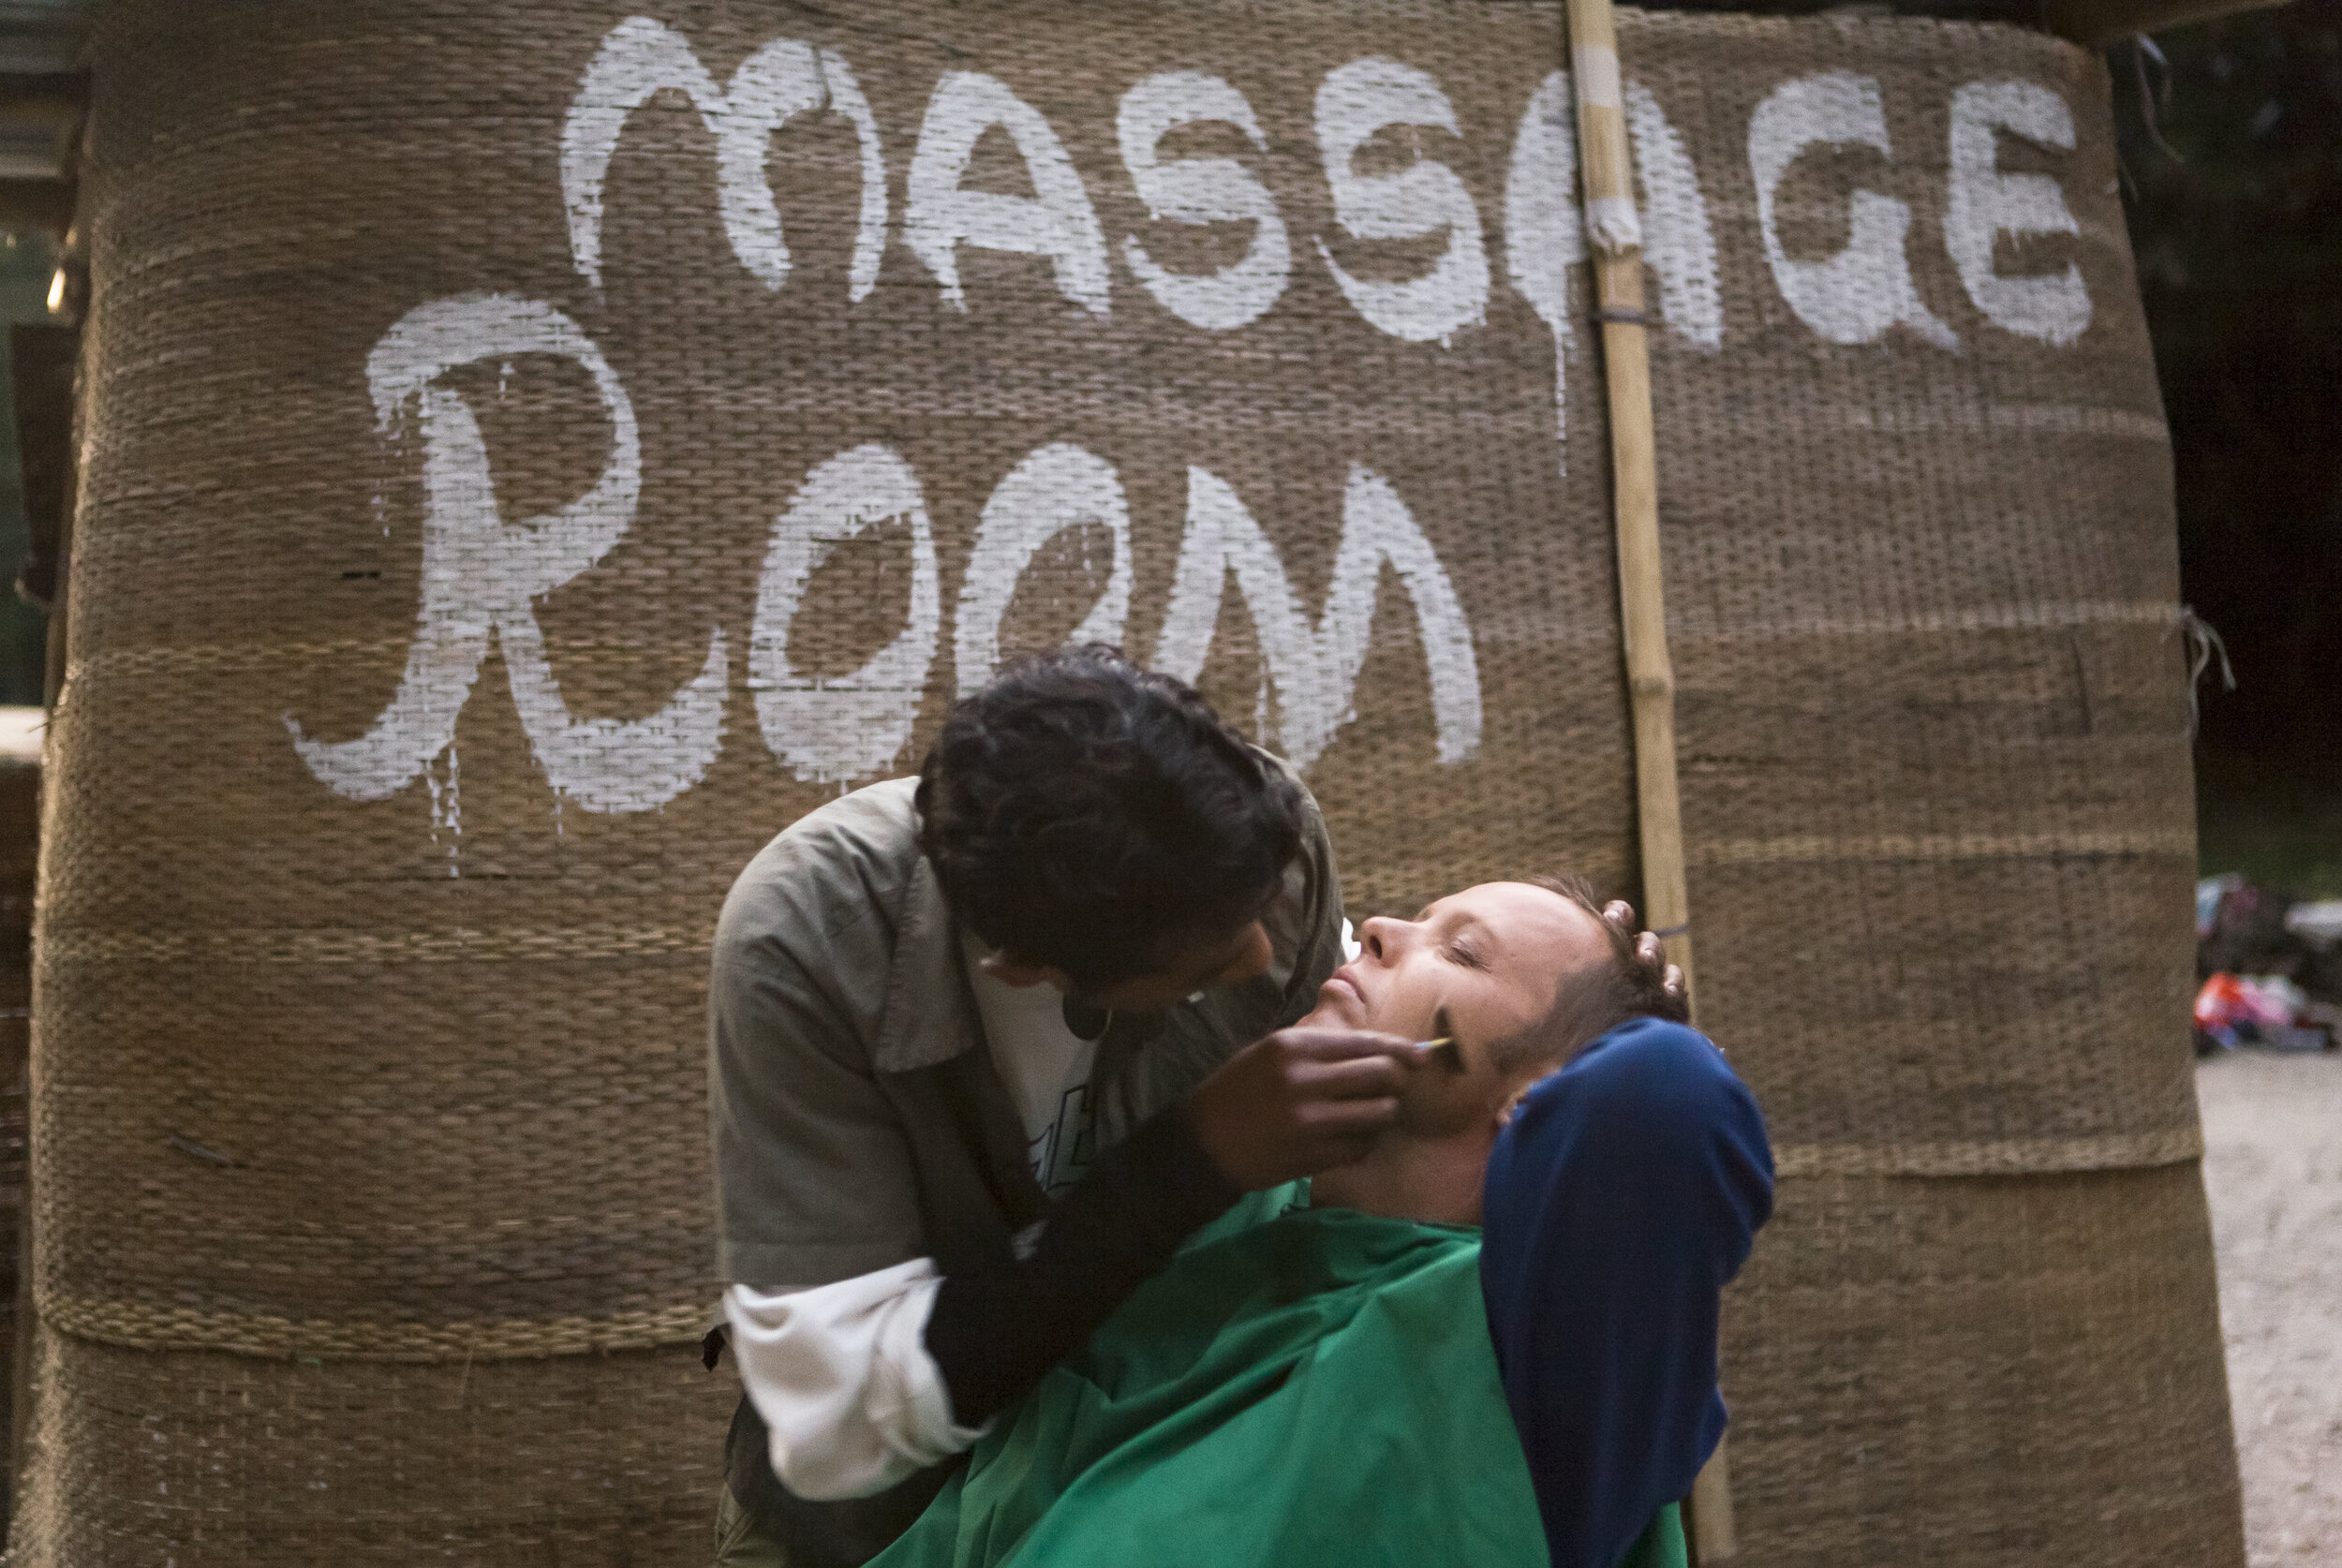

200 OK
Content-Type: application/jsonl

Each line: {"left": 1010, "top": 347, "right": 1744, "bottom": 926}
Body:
{"left": 1316, "top": 58, "right": 1488, "bottom": 344}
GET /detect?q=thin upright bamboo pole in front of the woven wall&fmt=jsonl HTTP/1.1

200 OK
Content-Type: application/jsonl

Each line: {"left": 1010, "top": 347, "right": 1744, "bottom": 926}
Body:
{"left": 1555, "top": 0, "right": 1741, "bottom": 1568}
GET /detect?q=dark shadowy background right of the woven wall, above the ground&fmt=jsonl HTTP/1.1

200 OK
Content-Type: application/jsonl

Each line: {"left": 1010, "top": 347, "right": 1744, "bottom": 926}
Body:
{"left": 2108, "top": 0, "right": 2342, "bottom": 898}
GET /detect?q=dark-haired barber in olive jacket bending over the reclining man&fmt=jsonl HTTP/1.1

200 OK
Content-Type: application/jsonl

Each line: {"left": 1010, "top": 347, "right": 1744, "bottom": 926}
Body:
{"left": 710, "top": 648, "right": 1696, "bottom": 1568}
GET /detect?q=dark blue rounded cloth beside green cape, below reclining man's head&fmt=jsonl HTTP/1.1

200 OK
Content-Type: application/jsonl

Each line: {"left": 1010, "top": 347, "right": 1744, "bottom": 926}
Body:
{"left": 1480, "top": 1018, "right": 1773, "bottom": 1568}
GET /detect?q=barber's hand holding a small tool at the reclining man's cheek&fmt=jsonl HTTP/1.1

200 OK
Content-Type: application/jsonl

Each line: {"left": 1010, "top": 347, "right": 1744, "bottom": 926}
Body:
{"left": 1188, "top": 1029, "right": 1415, "bottom": 1191}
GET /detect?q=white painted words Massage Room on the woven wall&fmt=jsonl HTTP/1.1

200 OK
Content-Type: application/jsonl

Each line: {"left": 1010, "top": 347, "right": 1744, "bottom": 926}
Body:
{"left": 286, "top": 16, "right": 2092, "bottom": 812}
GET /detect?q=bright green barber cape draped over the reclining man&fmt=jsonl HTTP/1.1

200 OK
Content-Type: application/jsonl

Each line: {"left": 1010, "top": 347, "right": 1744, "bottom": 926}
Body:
{"left": 874, "top": 1189, "right": 1684, "bottom": 1568}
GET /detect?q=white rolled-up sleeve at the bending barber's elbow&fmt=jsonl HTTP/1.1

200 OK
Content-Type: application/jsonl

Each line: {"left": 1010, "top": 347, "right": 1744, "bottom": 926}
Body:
{"left": 724, "top": 1257, "right": 988, "bottom": 1498}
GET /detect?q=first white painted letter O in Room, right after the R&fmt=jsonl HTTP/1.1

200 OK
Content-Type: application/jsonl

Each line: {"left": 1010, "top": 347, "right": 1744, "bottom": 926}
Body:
{"left": 748, "top": 442, "right": 944, "bottom": 782}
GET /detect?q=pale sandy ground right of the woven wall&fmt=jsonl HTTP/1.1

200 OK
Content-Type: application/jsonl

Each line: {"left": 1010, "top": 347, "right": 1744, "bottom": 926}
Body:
{"left": 2197, "top": 1051, "right": 2342, "bottom": 1568}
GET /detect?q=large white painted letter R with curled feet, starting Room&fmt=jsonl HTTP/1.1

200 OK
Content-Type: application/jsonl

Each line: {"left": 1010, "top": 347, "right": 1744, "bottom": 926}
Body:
{"left": 286, "top": 295, "right": 726, "bottom": 812}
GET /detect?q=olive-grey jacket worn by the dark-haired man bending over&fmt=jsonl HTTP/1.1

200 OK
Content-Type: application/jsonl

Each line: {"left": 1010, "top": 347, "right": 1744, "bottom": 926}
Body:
{"left": 707, "top": 754, "right": 1342, "bottom": 1290}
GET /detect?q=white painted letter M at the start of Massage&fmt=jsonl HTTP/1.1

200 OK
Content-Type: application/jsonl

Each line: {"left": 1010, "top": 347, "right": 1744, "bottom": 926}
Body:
{"left": 562, "top": 16, "right": 888, "bottom": 300}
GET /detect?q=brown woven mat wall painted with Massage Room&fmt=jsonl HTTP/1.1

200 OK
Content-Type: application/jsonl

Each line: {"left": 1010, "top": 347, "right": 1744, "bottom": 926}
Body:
{"left": 19, "top": 0, "right": 2239, "bottom": 1566}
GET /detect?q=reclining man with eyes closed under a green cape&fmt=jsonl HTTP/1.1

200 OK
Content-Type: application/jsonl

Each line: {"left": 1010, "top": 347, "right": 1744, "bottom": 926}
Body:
{"left": 876, "top": 882, "right": 1771, "bottom": 1568}
